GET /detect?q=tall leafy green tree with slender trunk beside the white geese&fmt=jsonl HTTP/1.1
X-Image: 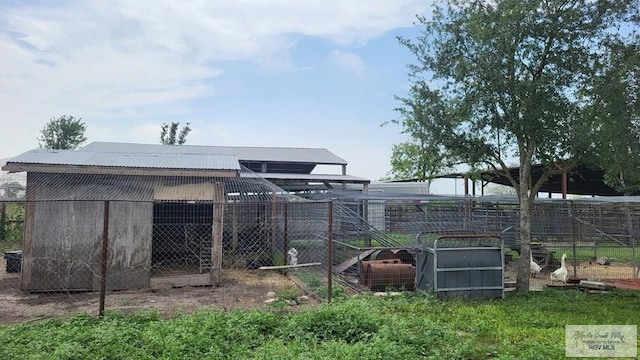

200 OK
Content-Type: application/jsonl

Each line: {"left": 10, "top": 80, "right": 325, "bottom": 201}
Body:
{"left": 399, "top": 0, "right": 638, "bottom": 291}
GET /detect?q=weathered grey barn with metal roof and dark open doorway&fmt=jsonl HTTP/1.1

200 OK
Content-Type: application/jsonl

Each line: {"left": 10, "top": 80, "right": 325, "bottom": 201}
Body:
{"left": 2, "top": 142, "right": 369, "bottom": 292}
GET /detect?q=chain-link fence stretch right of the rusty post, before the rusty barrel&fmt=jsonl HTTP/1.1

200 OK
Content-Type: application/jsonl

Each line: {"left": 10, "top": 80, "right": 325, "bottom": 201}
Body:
{"left": 334, "top": 195, "right": 640, "bottom": 291}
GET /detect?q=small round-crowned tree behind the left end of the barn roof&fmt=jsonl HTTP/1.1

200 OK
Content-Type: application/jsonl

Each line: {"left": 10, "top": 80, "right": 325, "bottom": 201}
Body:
{"left": 38, "top": 115, "right": 87, "bottom": 150}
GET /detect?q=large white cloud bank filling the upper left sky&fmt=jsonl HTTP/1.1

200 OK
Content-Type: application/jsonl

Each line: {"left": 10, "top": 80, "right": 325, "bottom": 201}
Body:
{"left": 0, "top": 0, "right": 428, "bottom": 163}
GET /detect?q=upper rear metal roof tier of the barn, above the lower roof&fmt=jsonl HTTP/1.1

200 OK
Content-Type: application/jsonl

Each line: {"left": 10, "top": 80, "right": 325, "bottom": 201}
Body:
{"left": 82, "top": 142, "right": 347, "bottom": 165}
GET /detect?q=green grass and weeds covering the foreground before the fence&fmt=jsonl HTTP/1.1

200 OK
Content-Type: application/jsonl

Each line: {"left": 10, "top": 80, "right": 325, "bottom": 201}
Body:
{"left": 0, "top": 290, "right": 640, "bottom": 359}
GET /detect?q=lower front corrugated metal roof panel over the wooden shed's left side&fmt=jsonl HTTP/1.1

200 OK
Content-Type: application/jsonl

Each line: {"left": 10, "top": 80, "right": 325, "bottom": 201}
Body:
{"left": 7, "top": 150, "right": 240, "bottom": 170}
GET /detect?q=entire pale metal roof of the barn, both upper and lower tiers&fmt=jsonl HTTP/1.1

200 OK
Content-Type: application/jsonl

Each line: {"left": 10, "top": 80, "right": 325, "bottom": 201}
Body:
{"left": 2, "top": 142, "right": 370, "bottom": 191}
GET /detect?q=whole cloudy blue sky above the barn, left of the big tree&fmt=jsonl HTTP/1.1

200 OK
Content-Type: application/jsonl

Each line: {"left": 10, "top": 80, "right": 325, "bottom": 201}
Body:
{"left": 0, "top": 0, "right": 460, "bottom": 194}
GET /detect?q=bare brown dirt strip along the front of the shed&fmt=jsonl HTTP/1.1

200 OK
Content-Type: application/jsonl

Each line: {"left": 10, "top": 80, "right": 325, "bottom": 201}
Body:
{"left": 0, "top": 258, "right": 320, "bottom": 324}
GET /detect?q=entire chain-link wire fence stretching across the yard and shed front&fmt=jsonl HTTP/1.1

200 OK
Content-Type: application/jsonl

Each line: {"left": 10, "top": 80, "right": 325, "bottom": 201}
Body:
{"left": 0, "top": 174, "right": 640, "bottom": 320}
